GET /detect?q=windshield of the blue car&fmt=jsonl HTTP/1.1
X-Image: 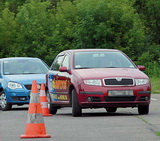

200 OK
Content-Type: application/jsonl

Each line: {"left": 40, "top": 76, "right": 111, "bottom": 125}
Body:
{"left": 3, "top": 59, "right": 48, "bottom": 75}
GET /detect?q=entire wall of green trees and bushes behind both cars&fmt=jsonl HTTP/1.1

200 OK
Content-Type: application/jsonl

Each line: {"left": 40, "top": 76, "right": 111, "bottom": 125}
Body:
{"left": 0, "top": 0, "right": 160, "bottom": 77}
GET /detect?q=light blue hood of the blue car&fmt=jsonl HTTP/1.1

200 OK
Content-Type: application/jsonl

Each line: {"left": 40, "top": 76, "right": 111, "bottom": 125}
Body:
{"left": 5, "top": 74, "right": 46, "bottom": 84}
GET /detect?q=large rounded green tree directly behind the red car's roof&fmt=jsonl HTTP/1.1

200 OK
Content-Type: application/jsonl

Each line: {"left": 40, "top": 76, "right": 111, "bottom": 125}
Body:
{"left": 55, "top": 0, "right": 145, "bottom": 59}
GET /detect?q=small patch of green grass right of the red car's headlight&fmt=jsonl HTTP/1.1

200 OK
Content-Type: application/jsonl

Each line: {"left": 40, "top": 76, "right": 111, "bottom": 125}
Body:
{"left": 150, "top": 77, "right": 160, "bottom": 94}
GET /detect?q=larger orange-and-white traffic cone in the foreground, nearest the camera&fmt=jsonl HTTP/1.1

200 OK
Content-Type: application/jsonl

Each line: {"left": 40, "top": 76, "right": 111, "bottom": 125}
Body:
{"left": 20, "top": 80, "right": 51, "bottom": 138}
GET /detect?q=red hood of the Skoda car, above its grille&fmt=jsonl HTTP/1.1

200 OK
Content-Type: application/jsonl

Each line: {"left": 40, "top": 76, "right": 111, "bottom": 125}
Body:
{"left": 75, "top": 68, "right": 148, "bottom": 79}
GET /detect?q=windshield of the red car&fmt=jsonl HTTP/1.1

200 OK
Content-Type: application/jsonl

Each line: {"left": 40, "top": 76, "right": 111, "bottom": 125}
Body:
{"left": 74, "top": 51, "right": 135, "bottom": 69}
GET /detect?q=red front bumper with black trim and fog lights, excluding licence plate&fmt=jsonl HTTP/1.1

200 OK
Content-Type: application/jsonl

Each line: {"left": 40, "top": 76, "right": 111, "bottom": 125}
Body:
{"left": 77, "top": 85, "right": 151, "bottom": 108}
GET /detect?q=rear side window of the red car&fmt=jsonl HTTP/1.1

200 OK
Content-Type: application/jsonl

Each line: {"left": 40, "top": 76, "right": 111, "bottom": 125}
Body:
{"left": 51, "top": 55, "right": 64, "bottom": 71}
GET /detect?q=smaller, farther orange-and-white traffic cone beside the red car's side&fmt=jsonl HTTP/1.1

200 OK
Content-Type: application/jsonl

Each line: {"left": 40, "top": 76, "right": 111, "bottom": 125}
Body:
{"left": 39, "top": 83, "right": 52, "bottom": 116}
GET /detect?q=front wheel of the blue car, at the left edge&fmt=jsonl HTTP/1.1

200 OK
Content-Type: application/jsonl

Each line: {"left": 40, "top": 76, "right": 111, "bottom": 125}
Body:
{"left": 0, "top": 91, "right": 12, "bottom": 111}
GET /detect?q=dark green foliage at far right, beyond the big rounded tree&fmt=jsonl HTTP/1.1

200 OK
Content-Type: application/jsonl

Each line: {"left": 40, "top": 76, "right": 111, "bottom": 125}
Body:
{"left": 135, "top": 0, "right": 160, "bottom": 77}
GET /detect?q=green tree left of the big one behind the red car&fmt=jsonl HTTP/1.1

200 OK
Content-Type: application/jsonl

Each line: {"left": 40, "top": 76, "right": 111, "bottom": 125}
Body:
{"left": 16, "top": 0, "right": 54, "bottom": 62}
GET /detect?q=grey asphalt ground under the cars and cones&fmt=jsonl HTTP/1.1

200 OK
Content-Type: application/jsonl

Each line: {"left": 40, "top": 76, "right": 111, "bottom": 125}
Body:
{"left": 0, "top": 94, "right": 160, "bottom": 141}
